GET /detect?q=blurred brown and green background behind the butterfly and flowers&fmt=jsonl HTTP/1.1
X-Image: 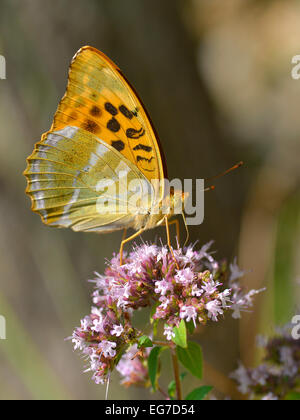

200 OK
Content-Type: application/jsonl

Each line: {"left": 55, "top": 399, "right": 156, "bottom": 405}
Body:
{"left": 0, "top": 0, "right": 300, "bottom": 399}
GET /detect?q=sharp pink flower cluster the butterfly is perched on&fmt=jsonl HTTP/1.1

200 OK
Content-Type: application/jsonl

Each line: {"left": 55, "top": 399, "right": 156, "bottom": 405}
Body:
{"left": 72, "top": 243, "right": 258, "bottom": 383}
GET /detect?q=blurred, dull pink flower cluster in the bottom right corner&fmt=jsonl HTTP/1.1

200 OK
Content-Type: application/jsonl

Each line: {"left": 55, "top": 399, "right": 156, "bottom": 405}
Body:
{"left": 231, "top": 325, "right": 300, "bottom": 400}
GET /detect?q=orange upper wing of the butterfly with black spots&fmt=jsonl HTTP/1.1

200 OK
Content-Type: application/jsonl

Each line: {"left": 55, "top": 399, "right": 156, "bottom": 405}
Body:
{"left": 50, "top": 46, "right": 166, "bottom": 197}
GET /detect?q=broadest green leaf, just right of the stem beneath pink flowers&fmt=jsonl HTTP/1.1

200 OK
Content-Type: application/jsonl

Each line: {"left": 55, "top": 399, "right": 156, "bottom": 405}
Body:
{"left": 176, "top": 341, "right": 203, "bottom": 379}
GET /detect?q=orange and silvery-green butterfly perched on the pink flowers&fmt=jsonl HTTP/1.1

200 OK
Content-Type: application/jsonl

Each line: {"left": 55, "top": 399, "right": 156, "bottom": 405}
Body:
{"left": 24, "top": 46, "right": 187, "bottom": 265}
